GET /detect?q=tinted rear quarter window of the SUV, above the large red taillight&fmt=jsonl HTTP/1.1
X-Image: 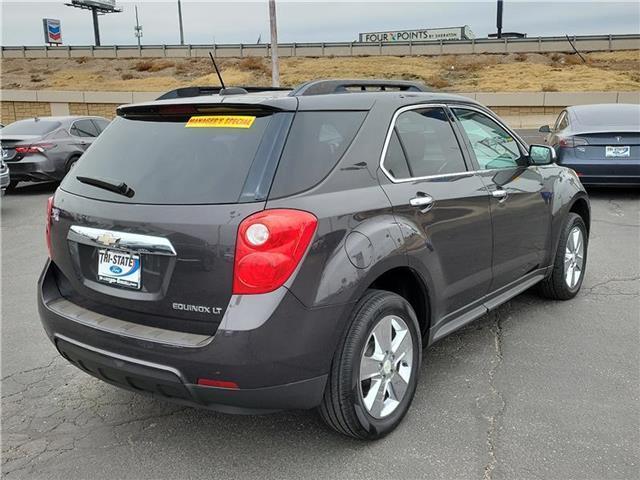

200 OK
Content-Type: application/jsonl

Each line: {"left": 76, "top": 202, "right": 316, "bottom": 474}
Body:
{"left": 269, "top": 111, "right": 366, "bottom": 198}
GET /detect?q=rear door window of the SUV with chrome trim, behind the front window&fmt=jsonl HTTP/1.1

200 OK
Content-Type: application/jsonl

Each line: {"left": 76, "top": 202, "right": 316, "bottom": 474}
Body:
{"left": 384, "top": 107, "right": 467, "bottom": 180}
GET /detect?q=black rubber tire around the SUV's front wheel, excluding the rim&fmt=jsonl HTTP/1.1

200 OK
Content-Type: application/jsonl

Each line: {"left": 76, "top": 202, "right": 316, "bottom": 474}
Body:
{"left": 538, "top": 213, "right": 589, "bottom": 300}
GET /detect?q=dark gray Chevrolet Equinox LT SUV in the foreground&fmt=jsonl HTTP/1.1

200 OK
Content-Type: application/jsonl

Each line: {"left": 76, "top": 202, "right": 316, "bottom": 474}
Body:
{"left": 39, "top": 80, "right": 590, "bottom": 439}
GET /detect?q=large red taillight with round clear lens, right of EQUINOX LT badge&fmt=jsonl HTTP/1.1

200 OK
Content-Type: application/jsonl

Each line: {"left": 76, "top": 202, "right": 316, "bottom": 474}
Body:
{"left": 233, "top": 210, "right": 318, "bottom": 295}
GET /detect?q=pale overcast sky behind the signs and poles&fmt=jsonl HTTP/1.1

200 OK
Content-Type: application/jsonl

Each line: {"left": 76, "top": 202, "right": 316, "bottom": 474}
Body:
{"left": 0, "top": 0, "right": 640, "bottom": 45}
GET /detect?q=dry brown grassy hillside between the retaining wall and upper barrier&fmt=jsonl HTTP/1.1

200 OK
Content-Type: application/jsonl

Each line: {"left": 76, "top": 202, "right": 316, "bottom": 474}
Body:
{"left": 0, "top": 51, "right": 640, "bottom": 92}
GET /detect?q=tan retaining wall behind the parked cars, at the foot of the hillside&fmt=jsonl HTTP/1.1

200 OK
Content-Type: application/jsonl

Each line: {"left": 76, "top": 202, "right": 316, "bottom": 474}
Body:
{"left": 0, "top": 90, "right": 640, "bottom": 128}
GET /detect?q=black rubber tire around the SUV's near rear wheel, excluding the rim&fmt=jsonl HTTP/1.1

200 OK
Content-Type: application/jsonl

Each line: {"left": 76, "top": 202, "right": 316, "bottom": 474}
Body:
{"left": 319, "top": 290, "right": 422, "bottom": 440}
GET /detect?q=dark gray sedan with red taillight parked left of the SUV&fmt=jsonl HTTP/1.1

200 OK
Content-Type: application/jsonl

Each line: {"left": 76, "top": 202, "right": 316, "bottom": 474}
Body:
{"left": 0, "top": 116, "right": 109, "bottom": 191}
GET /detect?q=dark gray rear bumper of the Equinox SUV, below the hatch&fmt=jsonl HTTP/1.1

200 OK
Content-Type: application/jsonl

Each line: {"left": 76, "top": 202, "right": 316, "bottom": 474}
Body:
{"left": 38, "top": 262, "right": 350, "bottom": 413}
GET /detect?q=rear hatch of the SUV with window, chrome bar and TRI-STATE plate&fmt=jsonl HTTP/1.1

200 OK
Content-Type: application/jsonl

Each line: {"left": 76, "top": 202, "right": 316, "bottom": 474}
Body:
{"left": 51, "top": 105, "right": 293, "bottom": 334}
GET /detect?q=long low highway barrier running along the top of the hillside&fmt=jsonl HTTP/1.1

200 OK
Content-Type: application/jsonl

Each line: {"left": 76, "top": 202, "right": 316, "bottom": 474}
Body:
{"left": 0, "top": 34, "right": 640, "bottom": 58}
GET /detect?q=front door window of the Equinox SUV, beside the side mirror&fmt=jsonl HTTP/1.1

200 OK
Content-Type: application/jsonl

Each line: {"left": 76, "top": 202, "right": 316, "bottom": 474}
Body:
{"left": 453, "top": 108, "right": 526, "bottom": 170}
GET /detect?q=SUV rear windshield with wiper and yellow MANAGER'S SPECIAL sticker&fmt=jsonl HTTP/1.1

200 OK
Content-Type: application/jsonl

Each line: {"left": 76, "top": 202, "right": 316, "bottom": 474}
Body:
{"left": 62, "top": 113, "right": 293, "bottom": 204}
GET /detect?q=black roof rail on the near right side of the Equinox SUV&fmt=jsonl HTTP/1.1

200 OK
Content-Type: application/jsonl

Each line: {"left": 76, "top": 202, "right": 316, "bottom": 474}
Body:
{"left": 290, "top": 80, "right": 431, "bottom": 97}
